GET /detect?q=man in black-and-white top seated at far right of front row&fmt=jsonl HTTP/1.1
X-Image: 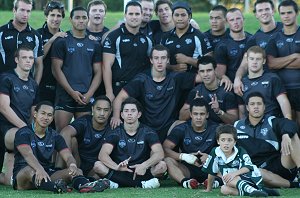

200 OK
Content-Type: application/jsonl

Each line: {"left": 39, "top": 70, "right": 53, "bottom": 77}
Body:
{"left": 234, "top": 92, "right": 300, "bottom": 188}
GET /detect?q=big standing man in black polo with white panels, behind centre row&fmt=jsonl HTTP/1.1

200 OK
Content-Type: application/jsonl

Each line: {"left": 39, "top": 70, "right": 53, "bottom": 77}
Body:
{"left": 103, "top": 1, "right": 152, "bottom": 101}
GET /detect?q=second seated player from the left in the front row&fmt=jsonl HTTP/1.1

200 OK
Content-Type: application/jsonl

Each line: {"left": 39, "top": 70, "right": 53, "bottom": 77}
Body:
{"left": 57, "top": 96, "right": 112, "bottom": 179}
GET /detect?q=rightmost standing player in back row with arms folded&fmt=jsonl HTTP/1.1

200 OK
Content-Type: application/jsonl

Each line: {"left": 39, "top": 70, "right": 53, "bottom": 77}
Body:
{"left": 266, "top": 0, "right": 300, "bottom": 125}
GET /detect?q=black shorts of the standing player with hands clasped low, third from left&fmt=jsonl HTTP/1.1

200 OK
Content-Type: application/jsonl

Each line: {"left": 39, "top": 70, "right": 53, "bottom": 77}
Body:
{"left": 55, "top": 87, "right": 92, "bottom": 113}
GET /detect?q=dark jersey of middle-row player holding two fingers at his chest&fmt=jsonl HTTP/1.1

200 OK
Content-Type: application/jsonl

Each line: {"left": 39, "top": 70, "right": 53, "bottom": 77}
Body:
{"left": 186, "top": 83, "right": 238, "bottom": 123}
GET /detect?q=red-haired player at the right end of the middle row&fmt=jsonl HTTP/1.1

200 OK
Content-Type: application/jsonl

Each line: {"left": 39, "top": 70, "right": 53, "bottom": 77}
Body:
{"left": 239, "top": 46, "right": 292, "bottom": 119}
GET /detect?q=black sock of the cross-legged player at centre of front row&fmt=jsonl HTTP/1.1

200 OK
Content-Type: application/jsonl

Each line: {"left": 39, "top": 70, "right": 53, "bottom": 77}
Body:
{"left": 104, "top": 170, "right": 142, "bottom": 187}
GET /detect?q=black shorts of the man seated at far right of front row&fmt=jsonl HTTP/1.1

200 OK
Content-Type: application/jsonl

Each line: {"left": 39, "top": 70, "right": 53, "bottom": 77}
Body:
{"left": 258, "top": 155, "right": 297, "bottom": 181}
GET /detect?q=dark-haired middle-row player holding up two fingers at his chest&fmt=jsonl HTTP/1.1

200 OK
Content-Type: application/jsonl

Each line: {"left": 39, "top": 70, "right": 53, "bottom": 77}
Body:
{"left": 179, "top": 56, "right": 238, "bottom": 124}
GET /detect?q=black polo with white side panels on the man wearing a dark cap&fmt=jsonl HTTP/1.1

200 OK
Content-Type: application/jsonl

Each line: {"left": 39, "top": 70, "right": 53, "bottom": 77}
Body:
{"left": 161, "top": 25, "right": 212, "bottom": 70}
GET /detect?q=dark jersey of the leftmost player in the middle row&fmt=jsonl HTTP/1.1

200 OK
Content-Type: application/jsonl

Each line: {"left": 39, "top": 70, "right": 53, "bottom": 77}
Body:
{"left": 0, "top": 70, "right": 38, "bottom": 124}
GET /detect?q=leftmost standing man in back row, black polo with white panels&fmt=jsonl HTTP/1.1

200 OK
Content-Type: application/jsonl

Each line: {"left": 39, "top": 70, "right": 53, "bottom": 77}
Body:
{"left": 0, "top": 0, "right": 43, "bottom": 83}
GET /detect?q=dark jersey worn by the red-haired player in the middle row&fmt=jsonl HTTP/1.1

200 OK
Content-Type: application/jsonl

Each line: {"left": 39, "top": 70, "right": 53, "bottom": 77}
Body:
{"left": 242, "top": 72, "right": 286, "bottom": 115}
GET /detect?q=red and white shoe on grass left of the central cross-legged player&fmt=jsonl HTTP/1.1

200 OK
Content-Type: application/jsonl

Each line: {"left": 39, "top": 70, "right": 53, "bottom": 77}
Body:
{"left": 79, "top": 179, "right": 110, "bottom": 193}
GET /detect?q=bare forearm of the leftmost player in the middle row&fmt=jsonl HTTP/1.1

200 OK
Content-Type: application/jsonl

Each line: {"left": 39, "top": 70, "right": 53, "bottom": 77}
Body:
{"left": 0, "top": 93, "right": 27, "bottom": 128}
